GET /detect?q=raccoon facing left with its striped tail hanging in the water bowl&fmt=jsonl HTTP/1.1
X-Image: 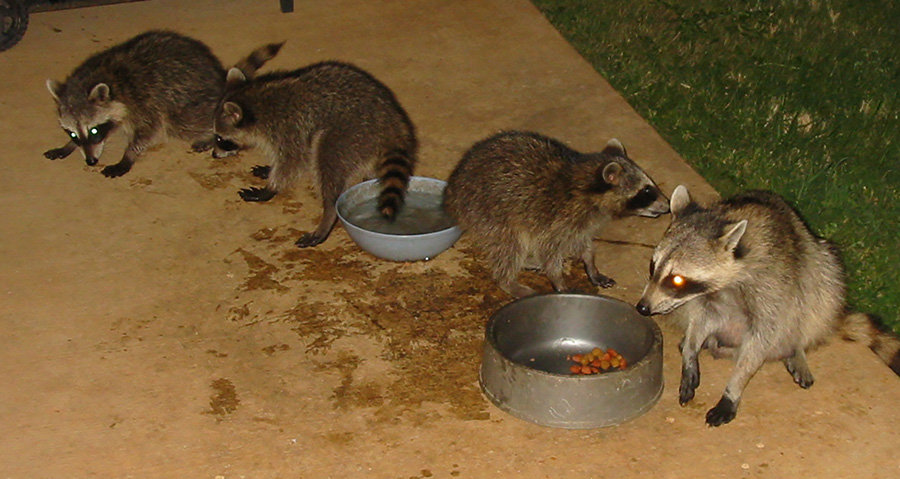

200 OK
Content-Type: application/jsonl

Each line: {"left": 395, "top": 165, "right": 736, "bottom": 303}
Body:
{"left": 213, "top": 61, "right": 418, "bottom": 248}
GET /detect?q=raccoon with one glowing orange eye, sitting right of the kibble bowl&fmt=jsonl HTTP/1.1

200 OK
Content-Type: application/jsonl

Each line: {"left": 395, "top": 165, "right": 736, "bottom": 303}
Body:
{"left": 637, "top": 186, "right": 900, "bottom": 426}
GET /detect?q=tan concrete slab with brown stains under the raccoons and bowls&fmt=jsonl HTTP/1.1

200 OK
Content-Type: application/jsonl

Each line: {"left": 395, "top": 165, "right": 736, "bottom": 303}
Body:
{"left": 0, "top": 0, "right": 900, "bottom": 479}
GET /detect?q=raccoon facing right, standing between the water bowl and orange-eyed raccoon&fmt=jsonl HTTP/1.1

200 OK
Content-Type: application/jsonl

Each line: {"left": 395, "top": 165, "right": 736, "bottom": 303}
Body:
{"left": 444, "top": 131, "right": 669, "bottom": 297}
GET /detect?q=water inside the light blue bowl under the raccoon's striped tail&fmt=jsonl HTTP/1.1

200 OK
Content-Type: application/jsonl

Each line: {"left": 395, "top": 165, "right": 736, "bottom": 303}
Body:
{"left": 344, "top": 191, "right": 454, "bottom": 235}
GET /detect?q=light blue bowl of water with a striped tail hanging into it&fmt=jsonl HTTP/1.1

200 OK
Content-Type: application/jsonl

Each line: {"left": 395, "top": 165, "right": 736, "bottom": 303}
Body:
{"left": 337, "top": 176, "right": 462, "bottom": 261}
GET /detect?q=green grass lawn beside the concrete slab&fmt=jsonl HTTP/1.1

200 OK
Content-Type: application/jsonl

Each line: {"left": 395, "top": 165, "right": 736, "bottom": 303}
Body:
{"left": 533, "top": 0, "right": 900, "bottom": 332}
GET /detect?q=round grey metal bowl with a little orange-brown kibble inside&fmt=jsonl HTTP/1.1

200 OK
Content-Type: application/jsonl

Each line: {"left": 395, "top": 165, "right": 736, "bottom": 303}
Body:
{"left": 479, "top": 294, "right": 663, "bottom": 429}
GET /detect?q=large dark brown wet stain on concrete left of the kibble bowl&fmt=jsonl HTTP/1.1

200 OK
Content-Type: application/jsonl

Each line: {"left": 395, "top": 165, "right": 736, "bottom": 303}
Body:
{"left": 221, "top": 232, "right": 524, "bottom": 424}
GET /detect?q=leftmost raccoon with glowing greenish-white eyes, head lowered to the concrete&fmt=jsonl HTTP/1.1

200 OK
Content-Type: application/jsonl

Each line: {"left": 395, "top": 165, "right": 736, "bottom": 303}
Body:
{"left": 44, "top": 30, "right": 281, "bottom": 178}
